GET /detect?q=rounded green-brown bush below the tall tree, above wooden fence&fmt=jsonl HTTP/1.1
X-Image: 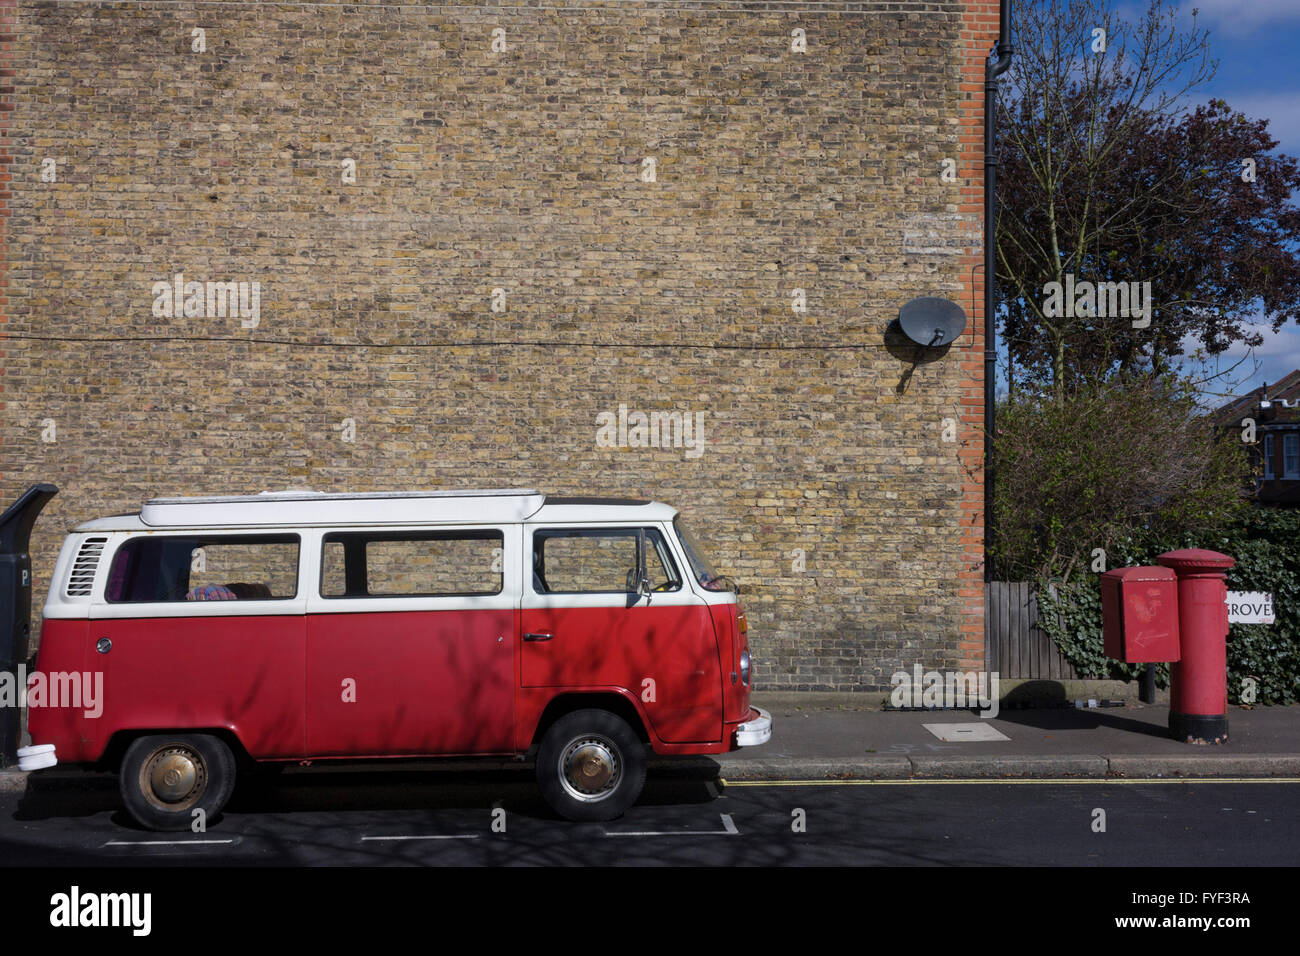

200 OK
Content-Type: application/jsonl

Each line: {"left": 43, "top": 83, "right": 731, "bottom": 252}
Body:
{"left": 995, "top": 376, "right": 1251, "bottom": 580}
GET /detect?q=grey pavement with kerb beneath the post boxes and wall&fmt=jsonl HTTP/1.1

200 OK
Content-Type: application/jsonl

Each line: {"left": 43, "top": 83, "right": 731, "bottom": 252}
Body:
{"left": 0, "top": 687, "right": 1300, "bottom": 792}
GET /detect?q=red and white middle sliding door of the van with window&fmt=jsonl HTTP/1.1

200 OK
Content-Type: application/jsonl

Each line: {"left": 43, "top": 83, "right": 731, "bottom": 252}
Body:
{"left": 307, "top": 525, "right": 520, "bottom": 757}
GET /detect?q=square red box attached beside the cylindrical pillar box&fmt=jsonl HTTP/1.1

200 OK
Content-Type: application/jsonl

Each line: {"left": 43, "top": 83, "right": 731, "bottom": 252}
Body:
{"left": 1101, "top": 567, "right": 1179, "bottom": 663}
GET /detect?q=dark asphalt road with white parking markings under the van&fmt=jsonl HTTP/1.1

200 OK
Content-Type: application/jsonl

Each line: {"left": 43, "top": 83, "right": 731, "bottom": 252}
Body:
{"left": 0, "top": 771, "right": 1300, "bottom": 868}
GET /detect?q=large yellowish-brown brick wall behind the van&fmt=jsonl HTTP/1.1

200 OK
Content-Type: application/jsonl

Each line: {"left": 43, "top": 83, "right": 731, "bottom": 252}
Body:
{"left": 0, "top": 0, "right": 997, "bottom": 689}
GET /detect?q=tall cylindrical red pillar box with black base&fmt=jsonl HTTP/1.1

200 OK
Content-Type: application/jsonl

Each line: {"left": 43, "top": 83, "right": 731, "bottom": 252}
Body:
{"left": 1156, "top": 548, "right": 1236, "bottom": 744}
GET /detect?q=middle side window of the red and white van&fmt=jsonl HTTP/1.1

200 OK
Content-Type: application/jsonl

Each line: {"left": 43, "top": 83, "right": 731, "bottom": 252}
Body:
{"left": 321, "top": 531, "right": 504, "bottom": 597}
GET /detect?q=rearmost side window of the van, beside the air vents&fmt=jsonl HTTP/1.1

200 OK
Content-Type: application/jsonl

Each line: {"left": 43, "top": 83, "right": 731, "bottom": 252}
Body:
{"left": 104, "top": 535, "right": 299, "bottom": 604}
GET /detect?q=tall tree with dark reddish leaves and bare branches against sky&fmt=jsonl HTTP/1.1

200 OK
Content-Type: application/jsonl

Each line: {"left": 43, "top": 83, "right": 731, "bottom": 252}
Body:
{"left": 997, "top": 0, "right": 1300, "bottom": 401}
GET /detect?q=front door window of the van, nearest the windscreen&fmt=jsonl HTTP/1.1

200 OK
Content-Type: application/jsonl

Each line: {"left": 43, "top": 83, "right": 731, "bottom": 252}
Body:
{"left": 533, "top": 528, "right": 681, "bottom": 594}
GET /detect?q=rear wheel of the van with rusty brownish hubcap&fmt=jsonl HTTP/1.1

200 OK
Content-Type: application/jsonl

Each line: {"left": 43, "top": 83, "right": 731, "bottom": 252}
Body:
{"left": 118, "top": 734, "right": 235, "bottom": 830}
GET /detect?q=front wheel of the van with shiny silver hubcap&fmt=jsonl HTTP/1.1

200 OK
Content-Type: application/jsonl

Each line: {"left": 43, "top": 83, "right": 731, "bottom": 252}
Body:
{"left": 537, "top": 710, "right": 646, "bottom": 822}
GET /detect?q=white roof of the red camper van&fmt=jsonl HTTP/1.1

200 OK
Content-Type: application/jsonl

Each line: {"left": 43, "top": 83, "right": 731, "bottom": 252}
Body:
{"left": 75, "top": 488, "right": 677, "bottom": 532}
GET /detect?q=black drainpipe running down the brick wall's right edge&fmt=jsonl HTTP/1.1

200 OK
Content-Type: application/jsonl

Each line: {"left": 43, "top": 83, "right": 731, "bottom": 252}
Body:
{"left": 984, "top": 0, "right": 1014, "bottom": 581}
